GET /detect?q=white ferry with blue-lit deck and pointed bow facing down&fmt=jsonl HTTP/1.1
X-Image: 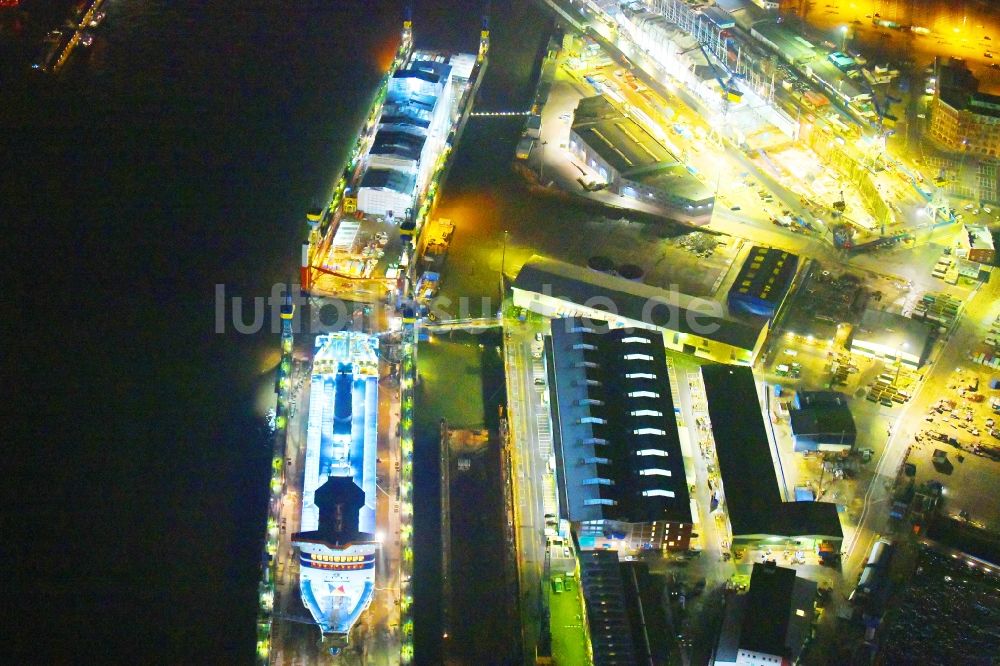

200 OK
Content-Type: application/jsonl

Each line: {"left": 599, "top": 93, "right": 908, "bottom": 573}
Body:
{"left": 292, "top": 331, "right": 379, "bottom": 650}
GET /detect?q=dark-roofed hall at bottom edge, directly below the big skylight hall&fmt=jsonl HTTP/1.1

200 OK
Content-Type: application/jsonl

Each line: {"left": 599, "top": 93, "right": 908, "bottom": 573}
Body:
{"left": 580, "top": 551, "right": 671, "bottom": 666}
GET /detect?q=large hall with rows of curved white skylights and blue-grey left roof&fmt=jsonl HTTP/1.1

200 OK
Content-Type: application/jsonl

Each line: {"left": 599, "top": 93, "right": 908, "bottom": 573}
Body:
{"left": 551, "top": 317, "right": 692, "bottom": 551}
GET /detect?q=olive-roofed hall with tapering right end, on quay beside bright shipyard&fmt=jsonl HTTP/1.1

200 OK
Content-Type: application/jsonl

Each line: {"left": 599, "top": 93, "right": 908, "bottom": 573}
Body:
{"left": 569, "top": 95, "right": 715, "bottom": 211}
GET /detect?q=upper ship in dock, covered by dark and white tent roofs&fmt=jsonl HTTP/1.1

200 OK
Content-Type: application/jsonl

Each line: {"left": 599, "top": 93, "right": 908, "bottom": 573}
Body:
{"left": 300, "top": 11, "right": 489, "bottom": 301}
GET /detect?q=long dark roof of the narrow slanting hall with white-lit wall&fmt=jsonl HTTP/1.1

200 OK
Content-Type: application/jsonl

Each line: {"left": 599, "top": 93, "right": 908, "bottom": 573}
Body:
{"left": 513, "top": 255, "right": 764, "bottom": 350}
